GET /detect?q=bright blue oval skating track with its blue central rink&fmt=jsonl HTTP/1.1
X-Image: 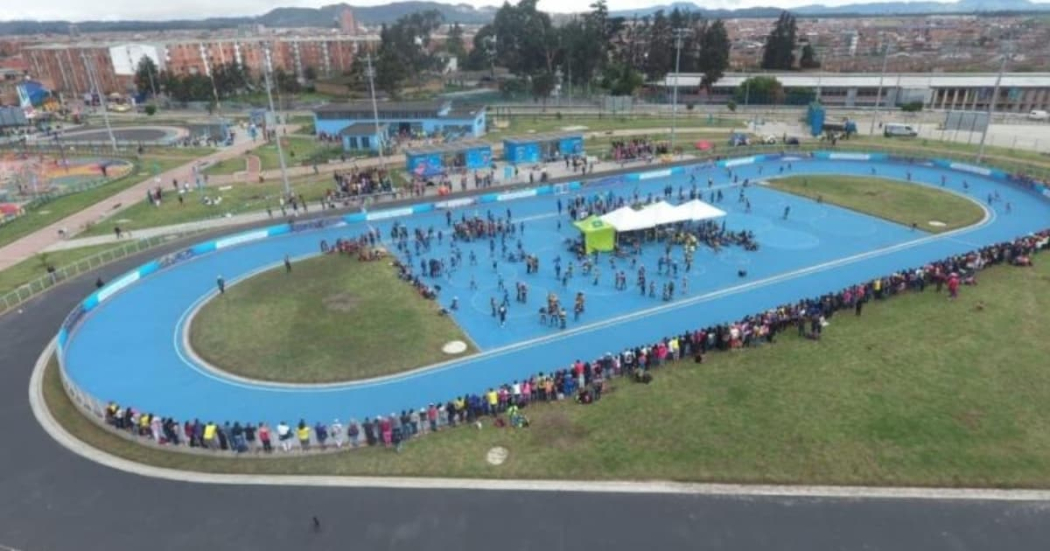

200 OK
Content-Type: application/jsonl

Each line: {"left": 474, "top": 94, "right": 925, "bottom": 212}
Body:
{"left": 59, "top": 154, "right": 1050, "bottom": 430}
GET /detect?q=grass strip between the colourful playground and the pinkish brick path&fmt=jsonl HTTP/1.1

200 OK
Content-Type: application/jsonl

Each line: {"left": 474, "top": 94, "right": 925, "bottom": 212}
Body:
{"left": 0, "top": 155, "right": 187, "bottom": 247}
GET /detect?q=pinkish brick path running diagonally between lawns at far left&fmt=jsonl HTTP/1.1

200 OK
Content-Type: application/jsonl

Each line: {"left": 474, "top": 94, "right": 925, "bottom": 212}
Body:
{"left": 0, "top": 127, "right": 292, "bottom": 270}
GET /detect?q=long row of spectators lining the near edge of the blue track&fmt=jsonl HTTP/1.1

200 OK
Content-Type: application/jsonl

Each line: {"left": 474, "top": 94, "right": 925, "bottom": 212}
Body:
{"left": 94, "top": 216, "right": 1050, "bottom": 453}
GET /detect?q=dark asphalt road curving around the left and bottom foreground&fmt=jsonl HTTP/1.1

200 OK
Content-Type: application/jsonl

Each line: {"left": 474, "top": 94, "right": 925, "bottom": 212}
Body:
{"left": 6, "top": 198, "right": 1050, "bottom": 551}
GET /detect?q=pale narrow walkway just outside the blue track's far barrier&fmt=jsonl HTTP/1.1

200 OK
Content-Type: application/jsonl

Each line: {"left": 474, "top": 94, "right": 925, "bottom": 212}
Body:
{"left": 46, "top": 155, "right": 691, "bottom": 251}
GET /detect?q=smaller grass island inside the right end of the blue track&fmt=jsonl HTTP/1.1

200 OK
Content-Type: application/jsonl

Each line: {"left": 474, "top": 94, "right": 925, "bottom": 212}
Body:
{"left": 769, "top": 175, "right": 984, "bottom": 233}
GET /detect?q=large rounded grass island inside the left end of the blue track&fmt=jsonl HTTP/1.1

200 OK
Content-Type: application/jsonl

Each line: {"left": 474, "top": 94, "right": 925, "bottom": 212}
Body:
{"left": 190, "top": 250, "right": 474, "bottom": 382}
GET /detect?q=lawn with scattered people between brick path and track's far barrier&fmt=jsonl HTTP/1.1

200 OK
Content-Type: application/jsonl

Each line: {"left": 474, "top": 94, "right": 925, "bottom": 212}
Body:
{"left": 81, "top": 175, "right": 333, "bottom": 237}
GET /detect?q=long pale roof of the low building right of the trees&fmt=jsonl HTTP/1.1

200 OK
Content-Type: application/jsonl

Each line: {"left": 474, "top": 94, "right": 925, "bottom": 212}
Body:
{"left": 663, "top": 72, "right": 1050, "bottom": 88}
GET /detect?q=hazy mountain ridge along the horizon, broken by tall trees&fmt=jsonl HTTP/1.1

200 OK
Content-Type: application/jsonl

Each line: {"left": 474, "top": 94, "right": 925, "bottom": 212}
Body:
{"left": 0, "top": 0, "right": 1050, "bottom": 36}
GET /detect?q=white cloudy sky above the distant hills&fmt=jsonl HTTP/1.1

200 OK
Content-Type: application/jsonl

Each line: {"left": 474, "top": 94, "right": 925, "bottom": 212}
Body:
{"left": 0, "top": 0, "right": 1003, "bottom": 21}
